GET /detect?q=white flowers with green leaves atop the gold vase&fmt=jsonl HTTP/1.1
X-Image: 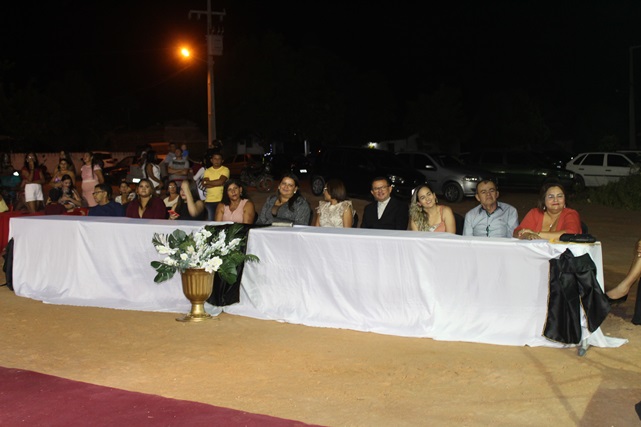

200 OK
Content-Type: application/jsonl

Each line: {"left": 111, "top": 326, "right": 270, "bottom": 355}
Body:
{"left": 151, "top": 224, "right": 258, "bottom": 283}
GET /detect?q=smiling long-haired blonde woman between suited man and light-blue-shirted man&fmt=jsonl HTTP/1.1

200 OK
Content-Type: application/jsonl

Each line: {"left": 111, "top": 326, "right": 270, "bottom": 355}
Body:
{"left": 409, "top": 184, "right": 456, "bottom": 234}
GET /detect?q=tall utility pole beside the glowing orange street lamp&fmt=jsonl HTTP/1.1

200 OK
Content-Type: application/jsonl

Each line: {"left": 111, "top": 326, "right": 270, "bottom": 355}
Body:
{"left": 188, "top": 0, "right": 227, "bottom": 149}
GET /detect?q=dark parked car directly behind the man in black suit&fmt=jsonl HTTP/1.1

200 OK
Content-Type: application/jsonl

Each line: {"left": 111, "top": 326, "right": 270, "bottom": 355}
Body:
{"left": 311, "top": 147, "right": 425, "bottom": 198}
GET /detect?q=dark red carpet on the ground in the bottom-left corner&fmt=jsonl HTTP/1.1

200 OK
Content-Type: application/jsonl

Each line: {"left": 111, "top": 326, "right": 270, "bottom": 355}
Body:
{"left": 0, "top": 367, "right": 320, "bottom": 427}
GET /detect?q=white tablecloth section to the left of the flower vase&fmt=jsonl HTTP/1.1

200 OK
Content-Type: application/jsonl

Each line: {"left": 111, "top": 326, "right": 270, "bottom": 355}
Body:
{"left": 9, "top": 216, "right": 212, "bottom": 312}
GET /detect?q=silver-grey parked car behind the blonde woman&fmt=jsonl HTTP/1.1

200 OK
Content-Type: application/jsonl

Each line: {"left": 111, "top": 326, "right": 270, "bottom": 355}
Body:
{"left": 396, "top": 152, "right": 493, "bottom": 202}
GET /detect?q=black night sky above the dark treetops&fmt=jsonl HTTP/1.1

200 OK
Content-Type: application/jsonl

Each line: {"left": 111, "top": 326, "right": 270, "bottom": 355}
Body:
{"left": 0, "top": 0, "right": 641, "bottom": 145}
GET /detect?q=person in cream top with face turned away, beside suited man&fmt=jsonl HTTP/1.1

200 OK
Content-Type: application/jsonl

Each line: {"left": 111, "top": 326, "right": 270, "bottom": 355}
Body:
{"left": 314, "top": 179, "right": 354, "bottom": 228}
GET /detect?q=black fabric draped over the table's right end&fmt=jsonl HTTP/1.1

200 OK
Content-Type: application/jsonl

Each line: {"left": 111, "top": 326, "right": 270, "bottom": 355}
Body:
{"left": 543, "top": 249, "right": 610, "bottom": 344}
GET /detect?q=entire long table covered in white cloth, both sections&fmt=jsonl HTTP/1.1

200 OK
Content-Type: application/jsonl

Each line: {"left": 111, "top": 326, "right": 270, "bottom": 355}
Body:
{"left": 11, "top": 216, "right": 624, "bottom": 346}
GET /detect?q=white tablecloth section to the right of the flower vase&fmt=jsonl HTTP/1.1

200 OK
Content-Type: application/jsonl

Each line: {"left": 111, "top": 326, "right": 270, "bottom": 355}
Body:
{"left": 225, "top": 227, "right": 625, "bottom": 346}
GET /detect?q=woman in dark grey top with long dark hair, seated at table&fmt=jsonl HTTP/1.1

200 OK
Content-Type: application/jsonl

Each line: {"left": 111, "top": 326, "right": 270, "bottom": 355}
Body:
{"left": 256, "top": 173, "right": 312, "bottom": 225}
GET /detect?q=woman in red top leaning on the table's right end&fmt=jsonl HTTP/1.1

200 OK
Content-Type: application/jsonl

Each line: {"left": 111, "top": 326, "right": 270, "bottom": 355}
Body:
{"left": 513, "top": 183, "right": 581, "bottom": 240}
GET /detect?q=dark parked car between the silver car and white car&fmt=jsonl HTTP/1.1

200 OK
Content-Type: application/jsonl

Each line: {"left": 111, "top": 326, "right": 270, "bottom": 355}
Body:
{"left": 465, "top": 150, "right": 580, "bottom": 190}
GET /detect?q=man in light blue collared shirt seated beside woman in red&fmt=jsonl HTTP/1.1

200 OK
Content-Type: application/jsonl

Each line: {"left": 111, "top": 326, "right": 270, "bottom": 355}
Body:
{"left": 463, "top": 180, "right": 519, "bottom": 237}
